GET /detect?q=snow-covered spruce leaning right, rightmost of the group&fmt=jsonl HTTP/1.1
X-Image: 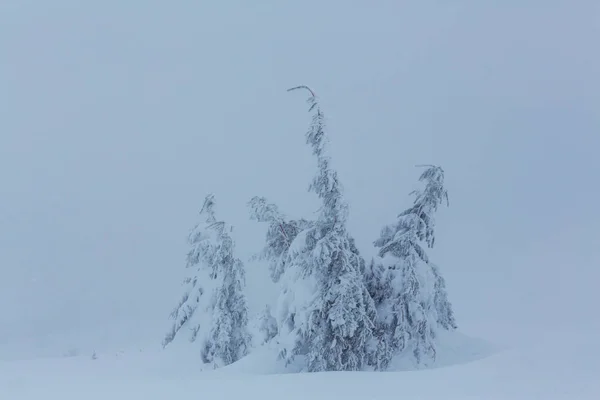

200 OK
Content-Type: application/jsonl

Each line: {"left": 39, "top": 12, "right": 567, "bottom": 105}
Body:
{"left": 367, "top": 166, "right": 456, "bottom": 369}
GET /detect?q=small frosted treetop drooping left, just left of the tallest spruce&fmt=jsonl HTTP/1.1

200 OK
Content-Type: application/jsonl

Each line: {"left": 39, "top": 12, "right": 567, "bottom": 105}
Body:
{"left": 248, "top": 197, "right": 312, "bottom": 283}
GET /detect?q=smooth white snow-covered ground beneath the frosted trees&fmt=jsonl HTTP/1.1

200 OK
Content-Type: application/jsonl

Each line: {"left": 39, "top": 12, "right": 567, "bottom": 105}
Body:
{"left": 0, "top": 325, "right": 600, "bottom": 400}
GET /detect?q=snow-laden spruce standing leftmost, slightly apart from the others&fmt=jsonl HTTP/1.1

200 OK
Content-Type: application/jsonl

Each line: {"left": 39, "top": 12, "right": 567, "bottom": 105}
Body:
{"left": 163, "top": 195, "right": 250, "bottom": 367}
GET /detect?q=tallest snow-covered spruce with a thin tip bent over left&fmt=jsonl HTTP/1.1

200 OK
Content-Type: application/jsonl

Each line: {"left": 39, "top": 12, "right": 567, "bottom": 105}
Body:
{"left": 276, "top": 86, "right": 375, "bottom": 372}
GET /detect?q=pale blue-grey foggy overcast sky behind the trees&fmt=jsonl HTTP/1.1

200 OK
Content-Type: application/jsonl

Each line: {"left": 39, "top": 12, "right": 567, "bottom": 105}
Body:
{"left": 0, "top": 0, "right": 600, "bottom": 350}
